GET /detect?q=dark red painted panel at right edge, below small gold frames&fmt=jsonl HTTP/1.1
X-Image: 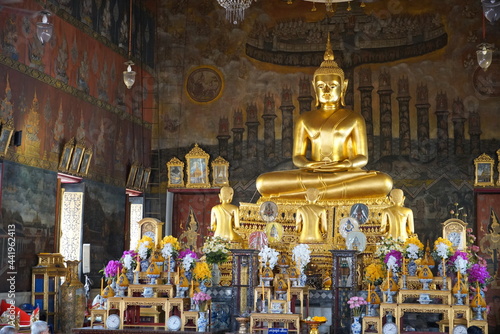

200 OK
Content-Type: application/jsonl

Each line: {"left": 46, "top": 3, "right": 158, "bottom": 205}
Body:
{"left": 474, "top": 188, "right": 500, "bottom": 302}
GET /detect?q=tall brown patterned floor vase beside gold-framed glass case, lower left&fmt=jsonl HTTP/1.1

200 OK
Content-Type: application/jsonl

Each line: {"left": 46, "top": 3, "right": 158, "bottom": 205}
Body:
{"left": 60, "top": 261, "right": 87, "bottom": 333}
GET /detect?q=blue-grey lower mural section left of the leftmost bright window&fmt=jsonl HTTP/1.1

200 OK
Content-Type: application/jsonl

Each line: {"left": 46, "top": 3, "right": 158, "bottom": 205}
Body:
{"left": 0, "top": 161, "right": 57, "bottom": 292}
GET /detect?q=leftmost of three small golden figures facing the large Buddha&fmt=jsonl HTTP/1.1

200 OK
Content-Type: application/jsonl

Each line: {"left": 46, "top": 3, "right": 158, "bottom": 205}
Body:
{"left": 210, "top": 187, "right": 242, "bottom": 242}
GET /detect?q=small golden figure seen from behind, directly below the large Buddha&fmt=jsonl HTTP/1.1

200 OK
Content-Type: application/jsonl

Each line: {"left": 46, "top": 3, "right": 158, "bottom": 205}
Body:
{"left": 295, "top": 188, "right": 327, "bottom": 243}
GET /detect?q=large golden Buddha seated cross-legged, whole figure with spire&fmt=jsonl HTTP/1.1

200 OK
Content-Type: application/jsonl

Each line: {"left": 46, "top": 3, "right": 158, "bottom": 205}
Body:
{"left": 257, "top": 37, "right": 392, "bottom": 200}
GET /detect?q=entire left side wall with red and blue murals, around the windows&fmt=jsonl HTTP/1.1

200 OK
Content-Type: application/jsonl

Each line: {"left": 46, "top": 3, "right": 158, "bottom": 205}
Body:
{"left": 0, "top": 0, "right": 155, "bottom": 291}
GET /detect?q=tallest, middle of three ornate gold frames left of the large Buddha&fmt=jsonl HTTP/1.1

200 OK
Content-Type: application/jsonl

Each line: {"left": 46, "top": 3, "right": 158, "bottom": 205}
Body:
{"left": 185, "top": 144, "right": 210, "bottom": 188}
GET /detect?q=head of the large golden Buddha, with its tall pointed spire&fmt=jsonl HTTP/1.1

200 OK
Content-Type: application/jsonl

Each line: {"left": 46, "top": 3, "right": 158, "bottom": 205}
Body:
{"left": 312, "top": 34, "right": 348, "bottom": 106}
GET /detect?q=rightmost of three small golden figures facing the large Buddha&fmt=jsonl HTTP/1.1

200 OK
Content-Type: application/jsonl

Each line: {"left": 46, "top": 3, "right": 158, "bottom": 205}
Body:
{"left": 380, "top": 189, "right": 415, "bottom": 241}
